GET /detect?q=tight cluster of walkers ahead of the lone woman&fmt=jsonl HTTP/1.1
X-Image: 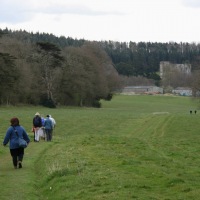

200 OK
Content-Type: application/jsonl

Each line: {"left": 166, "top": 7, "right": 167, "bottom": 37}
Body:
{"left": 32, "top": 112, "right": 56, "bottom": 142}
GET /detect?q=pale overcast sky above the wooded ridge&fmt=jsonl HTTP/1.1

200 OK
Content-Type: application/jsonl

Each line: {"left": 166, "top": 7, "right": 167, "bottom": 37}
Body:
{"left": 0, "top": 0, "right": 200, "bottom": 43}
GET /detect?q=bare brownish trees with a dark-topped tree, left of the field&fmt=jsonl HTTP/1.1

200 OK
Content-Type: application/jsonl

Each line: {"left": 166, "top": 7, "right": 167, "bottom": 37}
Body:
{"left": 0, "top": 30, "right": 119, "bottom": 107}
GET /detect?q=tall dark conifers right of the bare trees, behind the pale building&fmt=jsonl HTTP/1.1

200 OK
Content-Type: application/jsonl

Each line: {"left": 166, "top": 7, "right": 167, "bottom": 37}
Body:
{"left": 101, "top": 41, "right": 200, "bottom": 79}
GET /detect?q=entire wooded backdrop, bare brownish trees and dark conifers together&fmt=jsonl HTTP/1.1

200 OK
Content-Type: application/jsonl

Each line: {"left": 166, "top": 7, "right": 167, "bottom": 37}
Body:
{"left": 0, "top": 29, "right": 200, "bottom": 107}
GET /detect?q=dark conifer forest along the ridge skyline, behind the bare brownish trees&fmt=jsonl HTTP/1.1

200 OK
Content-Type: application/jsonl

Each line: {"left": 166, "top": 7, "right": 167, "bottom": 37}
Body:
{"left": 4, "top": 29, "right": 200, "bottom": 77}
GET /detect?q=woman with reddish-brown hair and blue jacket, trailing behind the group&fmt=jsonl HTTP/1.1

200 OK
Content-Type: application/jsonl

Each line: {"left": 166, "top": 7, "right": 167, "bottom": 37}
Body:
{"left": 3, "top": 117, "right": 30, "bottom": 169}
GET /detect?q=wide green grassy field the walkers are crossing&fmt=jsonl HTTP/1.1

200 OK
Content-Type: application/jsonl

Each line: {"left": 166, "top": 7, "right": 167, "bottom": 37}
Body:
{"left": 0, "top": 96, "right": 200, "bottom": 200}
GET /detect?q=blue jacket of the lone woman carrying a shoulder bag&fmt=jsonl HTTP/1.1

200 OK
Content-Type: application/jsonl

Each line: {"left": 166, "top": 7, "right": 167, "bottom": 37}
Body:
{"left": 3, "top": 126, "right": 30, "bottom": 149}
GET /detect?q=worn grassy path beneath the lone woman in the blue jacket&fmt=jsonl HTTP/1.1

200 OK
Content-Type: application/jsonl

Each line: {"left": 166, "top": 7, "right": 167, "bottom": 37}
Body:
{"left": 0, "top": 141, "right": 48, "bottom": 200}
